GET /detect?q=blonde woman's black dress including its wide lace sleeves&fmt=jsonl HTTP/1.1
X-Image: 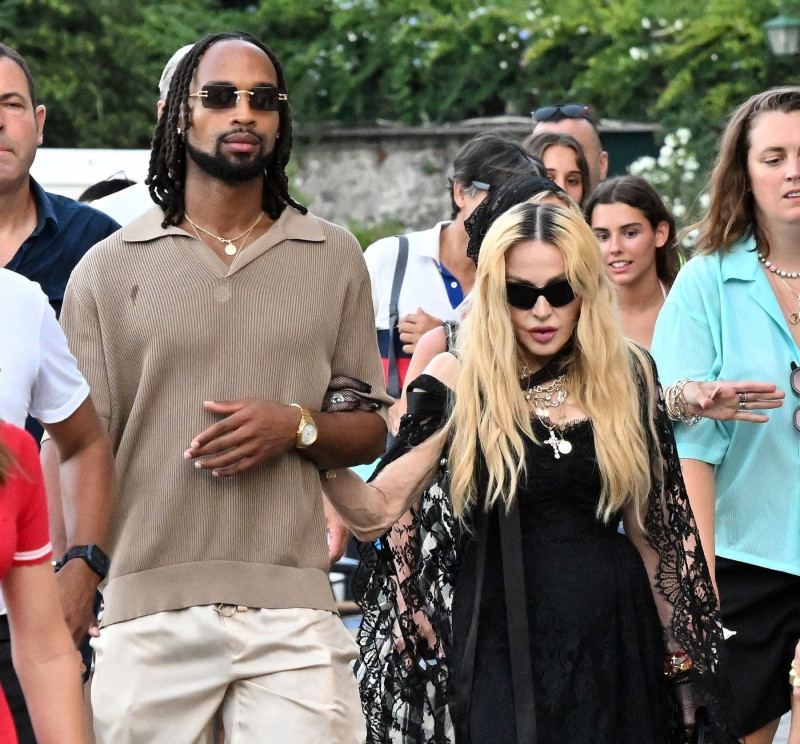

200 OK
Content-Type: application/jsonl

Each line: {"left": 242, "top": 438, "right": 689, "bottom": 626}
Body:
{"left": 354, "top": 360, "right": 735, "bottom": 744}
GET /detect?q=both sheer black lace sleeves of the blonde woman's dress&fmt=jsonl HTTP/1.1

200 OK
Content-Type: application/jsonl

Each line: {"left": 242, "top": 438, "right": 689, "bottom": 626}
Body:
{"left": 354, "top": 356, "right": 736, "bottom": 744}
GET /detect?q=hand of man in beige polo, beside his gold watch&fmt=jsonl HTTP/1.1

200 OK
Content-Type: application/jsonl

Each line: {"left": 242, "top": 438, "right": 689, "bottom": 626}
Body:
{"left": 183, "top": 398, "right": 300, "bottom": 477}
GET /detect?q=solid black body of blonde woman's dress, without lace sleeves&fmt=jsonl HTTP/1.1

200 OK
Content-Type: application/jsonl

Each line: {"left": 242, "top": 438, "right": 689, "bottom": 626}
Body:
{"left": 453, "top": 419, "right": 671, "bottom": 744}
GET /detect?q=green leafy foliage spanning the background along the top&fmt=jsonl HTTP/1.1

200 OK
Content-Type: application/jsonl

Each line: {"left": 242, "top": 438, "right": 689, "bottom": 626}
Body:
{"left": 0, "top": 0, "right": 800, "bottom": 159}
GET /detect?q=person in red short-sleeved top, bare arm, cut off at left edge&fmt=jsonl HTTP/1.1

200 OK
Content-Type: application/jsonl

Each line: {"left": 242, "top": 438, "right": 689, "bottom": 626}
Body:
{"left": 0, "top": 421, "right": 84, "bottom": 744}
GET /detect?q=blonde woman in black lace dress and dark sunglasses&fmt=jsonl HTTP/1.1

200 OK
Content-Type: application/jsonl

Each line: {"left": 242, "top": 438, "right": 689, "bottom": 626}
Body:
{"left": 326, "top": 204, "right": 729, "bottom": 744}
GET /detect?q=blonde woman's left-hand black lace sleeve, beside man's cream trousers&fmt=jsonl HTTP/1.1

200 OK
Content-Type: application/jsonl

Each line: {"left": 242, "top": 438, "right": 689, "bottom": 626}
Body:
{"left": 353, "top": 375, "right": 460, "bottom": 744}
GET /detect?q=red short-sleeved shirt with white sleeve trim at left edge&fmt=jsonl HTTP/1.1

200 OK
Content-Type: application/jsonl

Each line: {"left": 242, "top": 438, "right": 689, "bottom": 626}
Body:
{"left": 0, "top": 422, "right": 53, "bottom": 744}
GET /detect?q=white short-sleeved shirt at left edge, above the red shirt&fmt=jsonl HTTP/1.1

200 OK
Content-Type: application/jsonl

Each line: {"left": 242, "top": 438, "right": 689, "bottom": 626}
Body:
{"left": 0, "top": 269, "right": 89, "bottom": 427}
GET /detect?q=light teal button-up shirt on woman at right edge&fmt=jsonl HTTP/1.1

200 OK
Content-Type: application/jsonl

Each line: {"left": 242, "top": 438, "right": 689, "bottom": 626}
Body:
{"left": 652, "top": 238, "right": 800, "bottom": 575}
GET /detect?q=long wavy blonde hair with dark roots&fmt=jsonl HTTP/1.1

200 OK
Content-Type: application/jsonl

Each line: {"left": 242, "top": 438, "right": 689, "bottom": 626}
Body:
{"left": 443, "top": 203, "right": 653, "bottom": 522}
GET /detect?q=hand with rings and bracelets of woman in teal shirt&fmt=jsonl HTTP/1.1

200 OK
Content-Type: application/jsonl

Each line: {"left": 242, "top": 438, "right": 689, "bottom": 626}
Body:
{"left": 683, "top": 380, "right": 786, "bottom": 424}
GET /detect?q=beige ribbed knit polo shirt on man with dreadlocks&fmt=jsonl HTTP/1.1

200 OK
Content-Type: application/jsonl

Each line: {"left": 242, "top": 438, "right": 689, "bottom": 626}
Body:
{"left": 62, "top": 202, "right": 391, "bottom": 624}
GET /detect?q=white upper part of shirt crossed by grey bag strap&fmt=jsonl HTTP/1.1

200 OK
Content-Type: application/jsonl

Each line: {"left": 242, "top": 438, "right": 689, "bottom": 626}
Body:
{"left": 364, "top": 222, "right": 463, "bottom": 331}
